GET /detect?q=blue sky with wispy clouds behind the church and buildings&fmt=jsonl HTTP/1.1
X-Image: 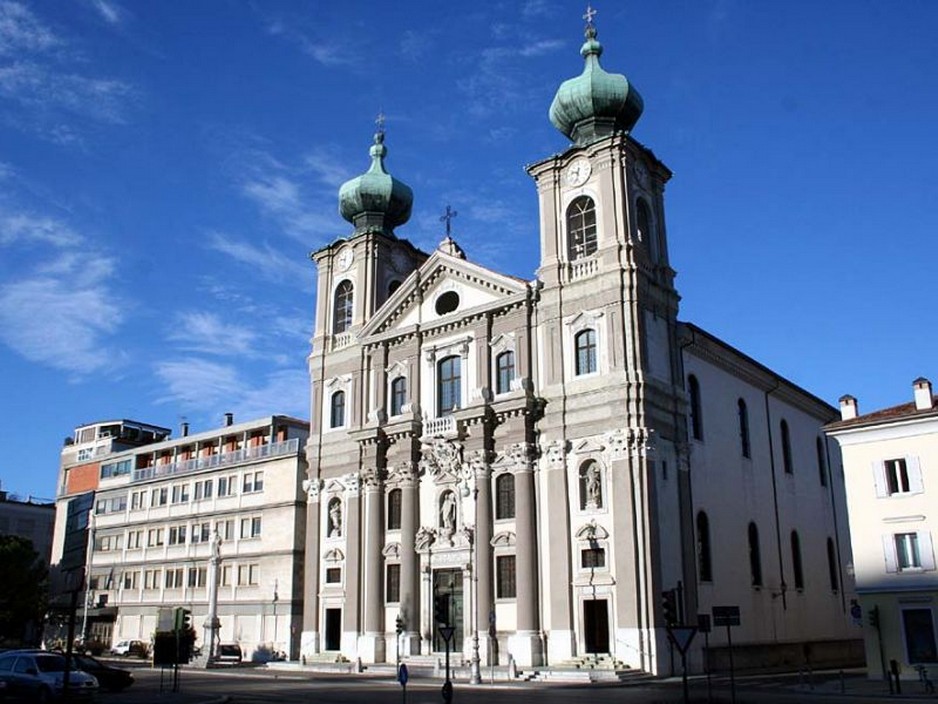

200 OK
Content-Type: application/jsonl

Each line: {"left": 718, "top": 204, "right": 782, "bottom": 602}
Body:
{"left": 0, "top": 0, "right": 938, "bottom": 496}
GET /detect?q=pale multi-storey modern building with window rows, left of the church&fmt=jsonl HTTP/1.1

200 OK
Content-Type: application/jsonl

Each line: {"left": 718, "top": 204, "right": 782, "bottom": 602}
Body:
{"left": 56, "top": 414, "right": 309, "bottom": 659}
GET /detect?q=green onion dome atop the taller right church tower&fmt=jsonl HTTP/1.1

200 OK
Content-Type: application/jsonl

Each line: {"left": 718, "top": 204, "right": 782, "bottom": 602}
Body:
{"left": 550, "top": 24, "right": 644, "bottom": 145}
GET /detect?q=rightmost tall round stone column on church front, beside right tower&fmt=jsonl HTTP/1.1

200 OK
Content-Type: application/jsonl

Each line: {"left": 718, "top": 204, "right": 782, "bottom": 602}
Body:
{"left": 508, "top": 443, "right": 544, "bottom": 667}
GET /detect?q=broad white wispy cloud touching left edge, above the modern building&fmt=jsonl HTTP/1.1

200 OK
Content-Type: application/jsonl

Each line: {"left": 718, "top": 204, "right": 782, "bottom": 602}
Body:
{"left": 0, "top": 254, "right": 124, "bottom": 374}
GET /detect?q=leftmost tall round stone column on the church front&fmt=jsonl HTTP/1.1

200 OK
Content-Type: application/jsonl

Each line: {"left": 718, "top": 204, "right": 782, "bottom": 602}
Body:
{"left": 358, "top": 468, "right": 386, "bottom": 663}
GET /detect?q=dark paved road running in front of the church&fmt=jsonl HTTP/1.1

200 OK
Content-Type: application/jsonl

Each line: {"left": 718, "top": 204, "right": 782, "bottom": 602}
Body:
{"left": 84, "top": 668, "right": 938, "bottom": 704}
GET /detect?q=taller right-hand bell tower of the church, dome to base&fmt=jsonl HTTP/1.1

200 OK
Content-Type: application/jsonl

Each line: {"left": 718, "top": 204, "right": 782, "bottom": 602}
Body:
{"left": 528, "top": 10, "right": 695, "bottom": 671}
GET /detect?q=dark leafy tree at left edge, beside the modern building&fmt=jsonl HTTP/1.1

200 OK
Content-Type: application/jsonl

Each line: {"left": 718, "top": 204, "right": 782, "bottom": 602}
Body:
{"left": 0, "top": 535, "right": 49, "bottom": 643}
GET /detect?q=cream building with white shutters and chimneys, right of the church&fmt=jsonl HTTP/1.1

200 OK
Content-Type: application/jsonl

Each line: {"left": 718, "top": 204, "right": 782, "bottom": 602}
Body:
{"left": 827, "top": 378, "right": 938, "bottom": 679}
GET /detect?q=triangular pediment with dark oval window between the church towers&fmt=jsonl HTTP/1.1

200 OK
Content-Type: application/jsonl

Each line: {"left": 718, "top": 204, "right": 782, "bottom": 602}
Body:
{"left": 359, "top": 250, "right": 528, "bottom": 341}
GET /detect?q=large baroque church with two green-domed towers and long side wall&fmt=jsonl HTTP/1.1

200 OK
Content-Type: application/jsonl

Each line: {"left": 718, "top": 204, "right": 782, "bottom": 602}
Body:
{"left": 301, "top": 20, "right": 860, "bottom": 674}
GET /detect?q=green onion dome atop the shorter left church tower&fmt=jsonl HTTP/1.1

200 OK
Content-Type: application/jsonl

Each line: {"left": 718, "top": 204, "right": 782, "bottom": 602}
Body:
{"left": 339, "top": 129, "right": 414, "bottom": 233}
